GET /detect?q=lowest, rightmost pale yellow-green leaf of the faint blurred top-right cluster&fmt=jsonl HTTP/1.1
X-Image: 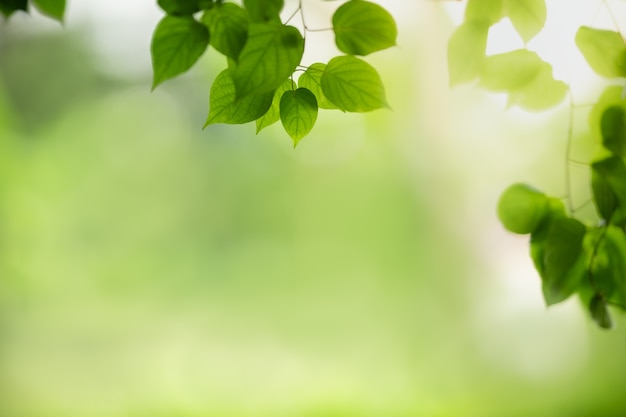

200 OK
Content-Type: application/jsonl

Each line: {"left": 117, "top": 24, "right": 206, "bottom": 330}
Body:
{"left": 508, "top": 62, "right": 568, "bottom": 111}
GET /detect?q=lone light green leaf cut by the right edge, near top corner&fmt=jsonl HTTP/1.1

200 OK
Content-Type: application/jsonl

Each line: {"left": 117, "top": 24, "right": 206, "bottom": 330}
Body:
{"left": 576, "top": 26, "right": 626, "bottom": 78}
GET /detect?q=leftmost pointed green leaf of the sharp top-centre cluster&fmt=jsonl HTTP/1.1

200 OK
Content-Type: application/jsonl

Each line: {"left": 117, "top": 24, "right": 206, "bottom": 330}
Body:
{"left": 150, "top": 16, "right": 209, "bottom": 90}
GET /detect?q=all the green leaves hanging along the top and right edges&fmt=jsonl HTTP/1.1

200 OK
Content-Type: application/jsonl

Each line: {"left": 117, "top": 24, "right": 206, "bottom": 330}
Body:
{"left": 0, "top": 0, "right": 626, "bottom": 328}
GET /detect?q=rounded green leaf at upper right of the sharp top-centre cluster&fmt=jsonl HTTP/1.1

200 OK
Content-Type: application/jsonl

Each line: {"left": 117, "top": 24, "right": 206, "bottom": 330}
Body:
{"left": 332, "top": 0, "right": 398, "bottom": 55}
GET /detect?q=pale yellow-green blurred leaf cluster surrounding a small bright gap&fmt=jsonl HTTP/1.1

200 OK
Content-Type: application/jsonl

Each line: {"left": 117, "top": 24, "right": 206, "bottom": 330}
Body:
{"left": 448, "top": 0, "right": 567, "bottom": 111}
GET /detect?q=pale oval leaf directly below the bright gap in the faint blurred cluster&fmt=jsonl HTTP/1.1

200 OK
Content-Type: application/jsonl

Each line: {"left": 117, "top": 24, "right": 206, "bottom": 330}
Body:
{"left": 480, "top": 49, "right": 544, "bottom": 91}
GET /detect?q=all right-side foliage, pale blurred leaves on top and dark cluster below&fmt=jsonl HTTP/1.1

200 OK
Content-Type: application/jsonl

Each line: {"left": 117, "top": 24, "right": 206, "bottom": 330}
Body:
{"left": 448, "top": 0, "right": 626, "bottom": 328}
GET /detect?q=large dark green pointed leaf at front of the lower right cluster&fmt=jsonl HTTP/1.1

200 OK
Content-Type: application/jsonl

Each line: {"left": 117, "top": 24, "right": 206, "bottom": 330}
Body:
{"left": 542, "top": 218, "right": 587, "bottom": 305}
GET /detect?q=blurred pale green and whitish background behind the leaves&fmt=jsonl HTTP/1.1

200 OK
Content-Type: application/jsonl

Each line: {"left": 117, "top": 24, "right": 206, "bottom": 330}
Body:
{"left": 0, "top": 6, "right": 626, "bottom": 417}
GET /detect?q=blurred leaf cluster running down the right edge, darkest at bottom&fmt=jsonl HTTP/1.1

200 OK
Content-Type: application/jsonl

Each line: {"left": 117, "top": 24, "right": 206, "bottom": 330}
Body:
{"left": 498, "top": 22, "right": 626, "bottom": 328}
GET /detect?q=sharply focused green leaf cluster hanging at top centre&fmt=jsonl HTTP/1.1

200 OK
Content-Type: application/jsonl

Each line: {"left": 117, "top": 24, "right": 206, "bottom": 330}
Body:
{"left": 151, "top": 0, "right": 397, "bottom": 146}
